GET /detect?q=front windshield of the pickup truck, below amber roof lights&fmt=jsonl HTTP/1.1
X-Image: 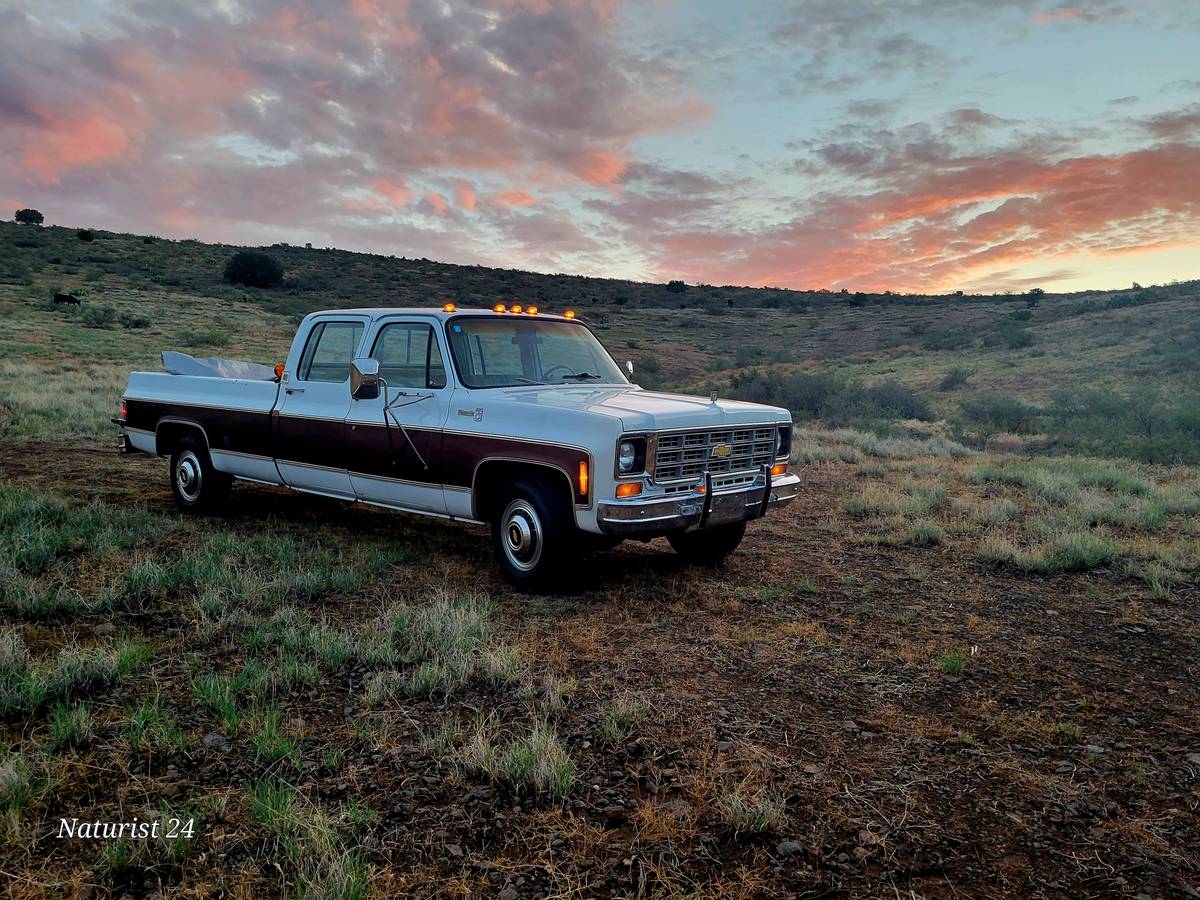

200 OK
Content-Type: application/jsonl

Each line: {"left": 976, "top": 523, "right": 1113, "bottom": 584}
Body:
{"left": 446, "top": 316, "right": 629, "bottom": 388}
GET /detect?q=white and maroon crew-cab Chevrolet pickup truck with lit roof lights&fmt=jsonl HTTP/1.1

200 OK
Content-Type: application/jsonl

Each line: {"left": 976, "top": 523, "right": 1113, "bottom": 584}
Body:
{"left": 114, "top": 305, "right": 799, "bottom": 587}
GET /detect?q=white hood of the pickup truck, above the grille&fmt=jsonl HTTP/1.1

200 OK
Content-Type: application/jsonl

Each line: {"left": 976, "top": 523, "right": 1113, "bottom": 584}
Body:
{"left": 492, "top": 385, "right": 791, "bottom": 431}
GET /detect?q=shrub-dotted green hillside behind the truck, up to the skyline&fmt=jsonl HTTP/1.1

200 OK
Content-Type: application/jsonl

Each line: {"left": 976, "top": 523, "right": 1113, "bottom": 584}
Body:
{"left": 0, "top": 223, "right": 1200, "bottom": 463}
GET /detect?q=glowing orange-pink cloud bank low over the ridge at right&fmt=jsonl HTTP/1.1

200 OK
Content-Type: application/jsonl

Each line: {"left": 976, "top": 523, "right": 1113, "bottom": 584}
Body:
{"left": 658, "top": 144, "right": 1200, "bottom": 290}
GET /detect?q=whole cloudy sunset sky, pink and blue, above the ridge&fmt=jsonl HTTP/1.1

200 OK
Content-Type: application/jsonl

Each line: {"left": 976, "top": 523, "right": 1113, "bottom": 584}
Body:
{"left": 0, "top": 0, "right": 1200, "bottom": 290}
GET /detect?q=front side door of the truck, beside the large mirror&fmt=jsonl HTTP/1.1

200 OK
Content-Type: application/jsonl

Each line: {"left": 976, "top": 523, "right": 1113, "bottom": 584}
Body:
{"left": 346, "top": 317, "right": 450, "bottom": 514}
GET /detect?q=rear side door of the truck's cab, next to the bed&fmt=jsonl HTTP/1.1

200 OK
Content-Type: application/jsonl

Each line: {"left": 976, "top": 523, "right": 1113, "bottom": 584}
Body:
{"left": 275, "top": 316, "right": 367, "bottom": 499}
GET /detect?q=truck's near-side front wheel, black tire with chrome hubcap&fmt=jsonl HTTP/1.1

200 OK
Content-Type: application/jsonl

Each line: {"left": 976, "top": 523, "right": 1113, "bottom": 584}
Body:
{"left": 492, "top": 475, "right": 577, "bottom": 590}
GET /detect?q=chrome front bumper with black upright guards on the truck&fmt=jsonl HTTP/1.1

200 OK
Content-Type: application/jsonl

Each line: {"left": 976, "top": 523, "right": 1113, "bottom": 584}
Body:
{"left": 596, "top": 473, "right": 800, "bottom": 538}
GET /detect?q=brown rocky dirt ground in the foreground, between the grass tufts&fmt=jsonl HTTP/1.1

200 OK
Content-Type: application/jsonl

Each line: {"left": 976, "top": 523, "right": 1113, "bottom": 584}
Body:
{"left": 0, "top": 445, "right": 1200, "bottom": 898}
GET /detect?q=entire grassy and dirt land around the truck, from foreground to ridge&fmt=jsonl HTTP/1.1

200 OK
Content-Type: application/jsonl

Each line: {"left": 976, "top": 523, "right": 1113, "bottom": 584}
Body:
{"left": 0, "top": 226, "right": 1200, "bottom": 898}
